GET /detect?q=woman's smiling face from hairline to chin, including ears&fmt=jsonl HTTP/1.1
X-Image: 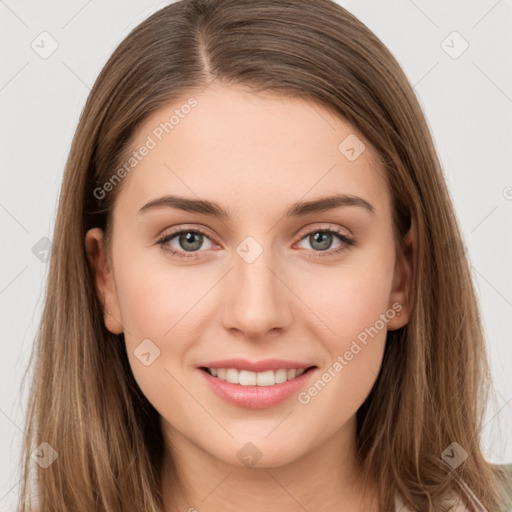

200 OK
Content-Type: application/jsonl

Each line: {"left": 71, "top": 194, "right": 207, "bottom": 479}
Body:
{"left": 86, "top": 84, "right": 410, "bottom": 467}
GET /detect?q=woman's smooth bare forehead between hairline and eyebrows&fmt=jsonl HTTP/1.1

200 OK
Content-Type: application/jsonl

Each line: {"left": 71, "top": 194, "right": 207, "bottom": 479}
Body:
{"left": 114, "top": 83, "right": 389, "bottom": 219}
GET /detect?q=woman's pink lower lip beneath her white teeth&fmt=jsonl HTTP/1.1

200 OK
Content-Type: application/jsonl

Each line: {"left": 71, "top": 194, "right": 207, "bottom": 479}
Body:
{"left": 199, "top": 368, "right": 316, "bottom": 409}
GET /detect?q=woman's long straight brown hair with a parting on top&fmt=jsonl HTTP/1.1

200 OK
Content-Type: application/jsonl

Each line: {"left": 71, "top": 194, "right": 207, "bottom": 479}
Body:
{"left": 20, "top": 0, "right": 510, "bottom": 512}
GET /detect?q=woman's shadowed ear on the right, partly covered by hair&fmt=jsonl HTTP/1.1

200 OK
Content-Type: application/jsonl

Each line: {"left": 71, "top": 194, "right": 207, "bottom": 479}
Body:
{"left": 388, "top": 219, "right": 417, "bottom": 331}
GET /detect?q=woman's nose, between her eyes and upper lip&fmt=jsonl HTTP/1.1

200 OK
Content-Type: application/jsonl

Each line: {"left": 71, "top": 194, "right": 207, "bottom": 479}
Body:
{"left": 222, "top": 241, "right": 293, "bottom": 341}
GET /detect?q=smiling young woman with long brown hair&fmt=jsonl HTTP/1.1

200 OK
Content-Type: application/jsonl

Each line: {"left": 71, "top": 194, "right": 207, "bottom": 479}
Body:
{"left": 21, "top": 0, "right": 507, "bottom": 512}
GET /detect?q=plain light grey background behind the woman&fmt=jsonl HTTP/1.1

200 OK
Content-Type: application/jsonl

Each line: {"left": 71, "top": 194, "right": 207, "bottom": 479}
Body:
{"left": 0, "top": 0, "right": 512, "bottom": 511}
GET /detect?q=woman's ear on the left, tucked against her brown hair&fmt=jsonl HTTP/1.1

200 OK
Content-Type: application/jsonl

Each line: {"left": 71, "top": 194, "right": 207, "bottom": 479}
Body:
{"left": 85, "top": 228, "right": 123, "bottom": 334}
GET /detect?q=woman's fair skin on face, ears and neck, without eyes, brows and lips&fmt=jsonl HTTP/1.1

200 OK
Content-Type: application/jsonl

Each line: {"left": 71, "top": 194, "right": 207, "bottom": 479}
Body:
{"left": 86, "top": 83, "right": 414, "bottom": 512}
